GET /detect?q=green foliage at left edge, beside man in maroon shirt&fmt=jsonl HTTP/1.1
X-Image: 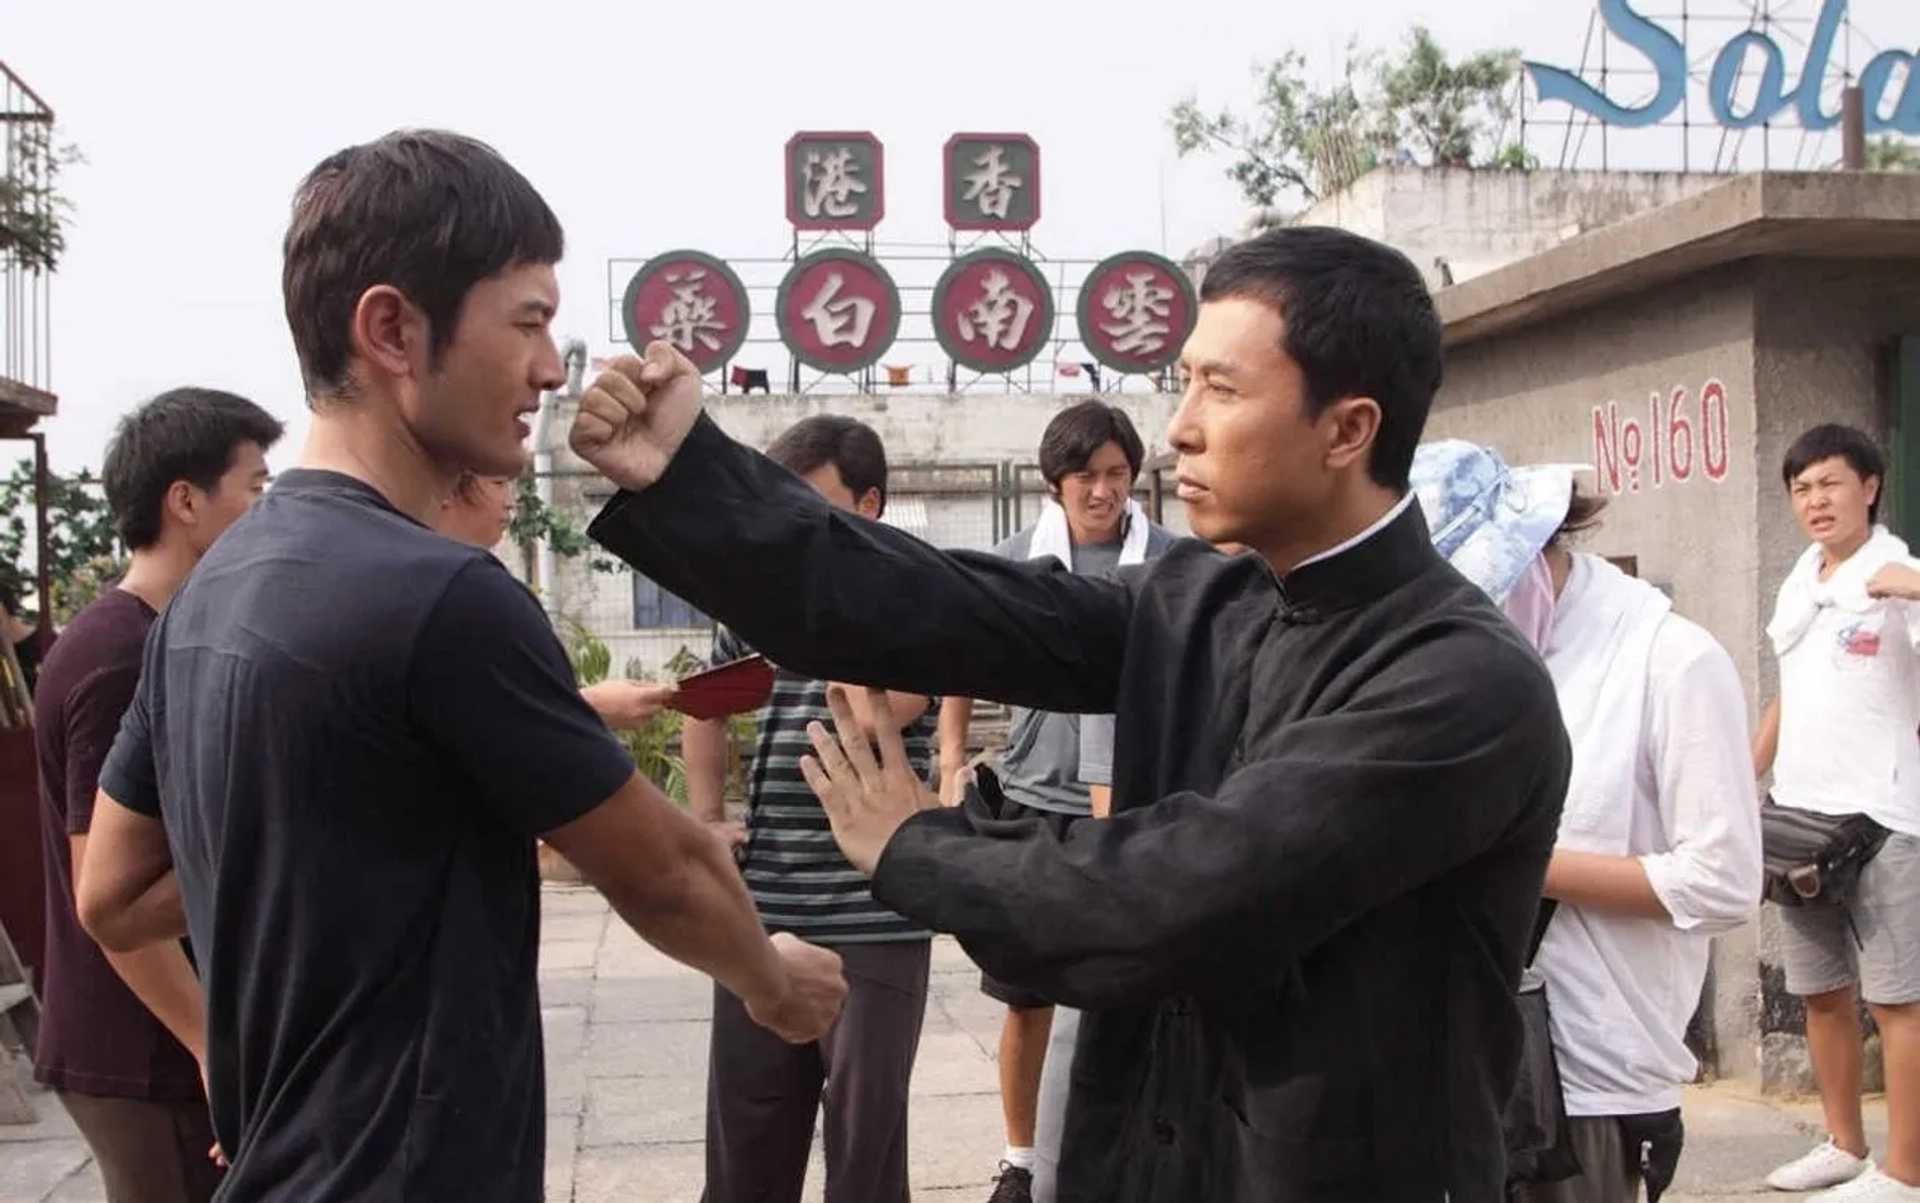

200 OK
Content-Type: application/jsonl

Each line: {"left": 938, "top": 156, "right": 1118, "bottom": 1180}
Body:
{"left": 0, "top": 459, "right": 125, "bottom": 622}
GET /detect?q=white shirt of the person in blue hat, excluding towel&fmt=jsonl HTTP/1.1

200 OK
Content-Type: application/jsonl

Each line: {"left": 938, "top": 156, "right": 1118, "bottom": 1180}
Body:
{"left": 1534, "top": 614, "right": 1761, "bottom": 1115}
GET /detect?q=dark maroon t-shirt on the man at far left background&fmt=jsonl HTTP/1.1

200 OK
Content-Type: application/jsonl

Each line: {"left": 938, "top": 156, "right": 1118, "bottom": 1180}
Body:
{"left": 33, "top": 589, "right": 202, "bottom": 1103}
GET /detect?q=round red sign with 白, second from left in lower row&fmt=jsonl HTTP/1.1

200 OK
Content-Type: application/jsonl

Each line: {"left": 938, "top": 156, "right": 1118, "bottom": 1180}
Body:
{"left": 774, "top": 248, "right": 900, "bottom": 372}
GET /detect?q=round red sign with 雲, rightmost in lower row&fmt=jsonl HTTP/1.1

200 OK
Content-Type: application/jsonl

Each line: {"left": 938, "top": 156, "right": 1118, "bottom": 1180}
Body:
{"left": 1079, "top": 251, "right": 1198, "bottom": 372}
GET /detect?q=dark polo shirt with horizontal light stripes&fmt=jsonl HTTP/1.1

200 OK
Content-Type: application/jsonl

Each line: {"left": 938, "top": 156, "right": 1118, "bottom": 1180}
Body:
{"left": 710, "top": 627, "right": 939, "bottom": 944}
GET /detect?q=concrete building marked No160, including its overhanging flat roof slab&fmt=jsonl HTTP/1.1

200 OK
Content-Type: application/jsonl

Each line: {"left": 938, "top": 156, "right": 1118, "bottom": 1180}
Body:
{"left": 1428, "top": 173, "right": 1920, "bottom": 1090}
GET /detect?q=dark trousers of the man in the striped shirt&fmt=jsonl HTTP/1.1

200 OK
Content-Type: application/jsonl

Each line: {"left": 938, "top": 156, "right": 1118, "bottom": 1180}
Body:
{"left": 701, "top": 940, "right": 931, "bottom": 1203}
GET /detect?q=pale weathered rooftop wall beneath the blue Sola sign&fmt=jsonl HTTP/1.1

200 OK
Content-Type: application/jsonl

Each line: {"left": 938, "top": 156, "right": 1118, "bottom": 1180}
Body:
{"left": 1294, "top": 167, "right": 1726, "bottom": 288}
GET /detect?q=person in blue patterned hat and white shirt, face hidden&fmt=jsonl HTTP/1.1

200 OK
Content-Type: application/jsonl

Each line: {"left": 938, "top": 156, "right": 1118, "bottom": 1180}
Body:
{"left": 1413, "top": 441, "right": 1761, "bottom": 1203}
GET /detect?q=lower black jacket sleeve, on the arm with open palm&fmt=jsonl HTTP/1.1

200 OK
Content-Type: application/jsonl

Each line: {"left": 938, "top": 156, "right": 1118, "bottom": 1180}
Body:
{"left": 874, "top": 639, "right": 1571, "bottom": 1009}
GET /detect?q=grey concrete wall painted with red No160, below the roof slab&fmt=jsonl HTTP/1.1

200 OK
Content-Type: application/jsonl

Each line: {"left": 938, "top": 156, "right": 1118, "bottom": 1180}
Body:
{"left": 1428, "top": 259, "right": 1920, "bottom": 1092}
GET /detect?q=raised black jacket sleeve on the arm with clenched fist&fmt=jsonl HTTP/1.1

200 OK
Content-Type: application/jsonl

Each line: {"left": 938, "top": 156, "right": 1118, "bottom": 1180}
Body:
{"left": 588, "top": 416, "right": 1133, "bottom": 712}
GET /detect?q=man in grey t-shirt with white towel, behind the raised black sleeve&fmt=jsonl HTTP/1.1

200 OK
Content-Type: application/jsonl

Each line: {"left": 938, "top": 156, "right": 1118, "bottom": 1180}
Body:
{"left": 941, "top": 399, "right": 1173, "bottom": 1203}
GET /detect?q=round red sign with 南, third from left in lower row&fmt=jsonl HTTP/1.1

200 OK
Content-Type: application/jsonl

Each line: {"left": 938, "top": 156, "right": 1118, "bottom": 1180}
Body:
{"left": 933, "top": 249, "right": 1054, "bottom": 372}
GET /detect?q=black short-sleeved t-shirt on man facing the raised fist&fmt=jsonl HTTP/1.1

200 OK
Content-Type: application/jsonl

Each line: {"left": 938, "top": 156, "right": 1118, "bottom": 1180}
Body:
{"left": 100, "top": 470, "right": 634, "bottom": 1203}
